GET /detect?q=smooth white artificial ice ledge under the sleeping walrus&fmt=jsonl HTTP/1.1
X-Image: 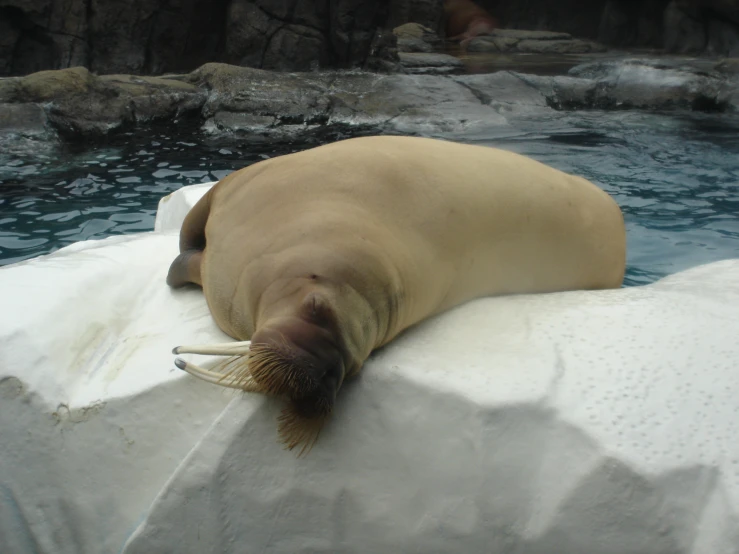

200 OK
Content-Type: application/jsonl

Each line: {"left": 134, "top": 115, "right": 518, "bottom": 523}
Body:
{"left": 0, "top": 186, "right": 739, "bottom": 554}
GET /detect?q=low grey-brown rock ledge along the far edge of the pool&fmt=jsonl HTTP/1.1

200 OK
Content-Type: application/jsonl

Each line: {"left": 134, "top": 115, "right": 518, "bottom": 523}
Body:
{"left": 0, "top": 54, "right": 739, "bottom": 151}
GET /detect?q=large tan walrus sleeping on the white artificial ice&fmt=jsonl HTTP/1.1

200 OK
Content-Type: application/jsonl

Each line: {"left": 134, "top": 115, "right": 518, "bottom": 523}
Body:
{"left": 167, "top": 136, "right": 626, "bottom": 451}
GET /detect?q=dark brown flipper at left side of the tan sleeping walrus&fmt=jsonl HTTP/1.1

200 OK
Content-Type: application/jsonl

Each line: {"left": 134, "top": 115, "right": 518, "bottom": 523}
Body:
{"left": 167, "top": 188, "right": 213, "bottom": 288}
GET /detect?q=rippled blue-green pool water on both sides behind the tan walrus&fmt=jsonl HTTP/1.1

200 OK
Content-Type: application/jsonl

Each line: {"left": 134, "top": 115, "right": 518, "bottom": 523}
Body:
{"left": 0, "top": 112, "right": 739, "bottom": 285}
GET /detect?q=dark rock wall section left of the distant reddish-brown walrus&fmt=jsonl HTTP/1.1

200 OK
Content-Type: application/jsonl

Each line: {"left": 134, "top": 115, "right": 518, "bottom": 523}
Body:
{"left": 0, "top": 0, "right": 428, "bottom": 75}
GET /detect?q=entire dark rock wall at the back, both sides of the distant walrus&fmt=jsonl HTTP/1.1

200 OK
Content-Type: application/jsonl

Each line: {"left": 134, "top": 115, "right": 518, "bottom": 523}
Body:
{"left": 0, "top": 0, "right": 739, "bottom": 76}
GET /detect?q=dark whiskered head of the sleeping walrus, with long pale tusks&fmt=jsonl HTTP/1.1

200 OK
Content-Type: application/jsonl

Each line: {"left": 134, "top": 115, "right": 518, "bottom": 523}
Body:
{"left": 173, "top": 286, "right": 368, "bottom": 454}
